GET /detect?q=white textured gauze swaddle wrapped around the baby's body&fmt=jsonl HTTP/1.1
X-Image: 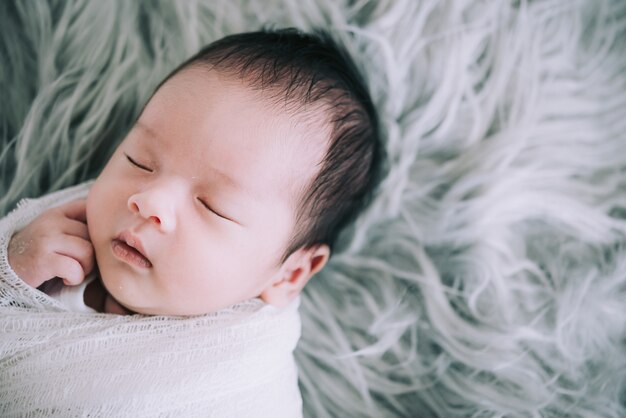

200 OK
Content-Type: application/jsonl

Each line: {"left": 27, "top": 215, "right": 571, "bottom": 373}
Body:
{"left": 0, "top": 182, "right": 302, "bottom": 418}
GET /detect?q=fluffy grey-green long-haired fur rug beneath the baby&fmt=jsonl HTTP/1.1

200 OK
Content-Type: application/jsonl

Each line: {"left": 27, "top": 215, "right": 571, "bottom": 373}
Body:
{"left": 0, "top": 0, "right": 626, "bottom": 417}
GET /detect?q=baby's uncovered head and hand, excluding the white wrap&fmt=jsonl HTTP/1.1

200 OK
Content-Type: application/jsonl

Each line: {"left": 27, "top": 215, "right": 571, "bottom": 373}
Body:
{"left": 8, "top": 30, "right": 381, "bottom": 316}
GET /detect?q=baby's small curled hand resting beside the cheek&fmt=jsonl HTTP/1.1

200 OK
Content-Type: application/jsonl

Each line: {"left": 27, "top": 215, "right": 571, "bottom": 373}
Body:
{"left": 8, "top": 199, "right": 95, "bottom": 287}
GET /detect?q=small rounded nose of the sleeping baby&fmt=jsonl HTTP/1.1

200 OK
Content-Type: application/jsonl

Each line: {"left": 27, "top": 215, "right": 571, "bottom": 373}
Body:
{"left": 128, "top": 188, "right": 176, "bottom": 232}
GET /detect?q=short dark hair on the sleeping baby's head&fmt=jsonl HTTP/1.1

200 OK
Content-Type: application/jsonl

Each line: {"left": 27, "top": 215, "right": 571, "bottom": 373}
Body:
{"left": 157, "top": 28, "right": 383, "bottom": 261}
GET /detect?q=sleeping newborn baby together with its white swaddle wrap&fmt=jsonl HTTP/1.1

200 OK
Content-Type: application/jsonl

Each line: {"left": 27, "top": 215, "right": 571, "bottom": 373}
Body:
{"left": 0, "top": 30, "right": 381, "bottom": 418}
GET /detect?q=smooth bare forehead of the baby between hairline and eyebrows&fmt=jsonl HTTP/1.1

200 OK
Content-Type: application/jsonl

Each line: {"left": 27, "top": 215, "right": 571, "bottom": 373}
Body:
{"left": 137, "top": 67, "right": 330, "bottom": 202}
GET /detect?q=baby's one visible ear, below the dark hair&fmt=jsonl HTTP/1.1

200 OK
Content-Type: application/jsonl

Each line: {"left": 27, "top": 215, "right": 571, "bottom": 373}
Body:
{"left": 260, "top": 244, "right": 330, "bottom": 308}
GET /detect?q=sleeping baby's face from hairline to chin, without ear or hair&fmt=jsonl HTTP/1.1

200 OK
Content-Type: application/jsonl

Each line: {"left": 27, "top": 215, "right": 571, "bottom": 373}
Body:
{"left": 87, "top": 68, "right": 324, "bottom": 315}
